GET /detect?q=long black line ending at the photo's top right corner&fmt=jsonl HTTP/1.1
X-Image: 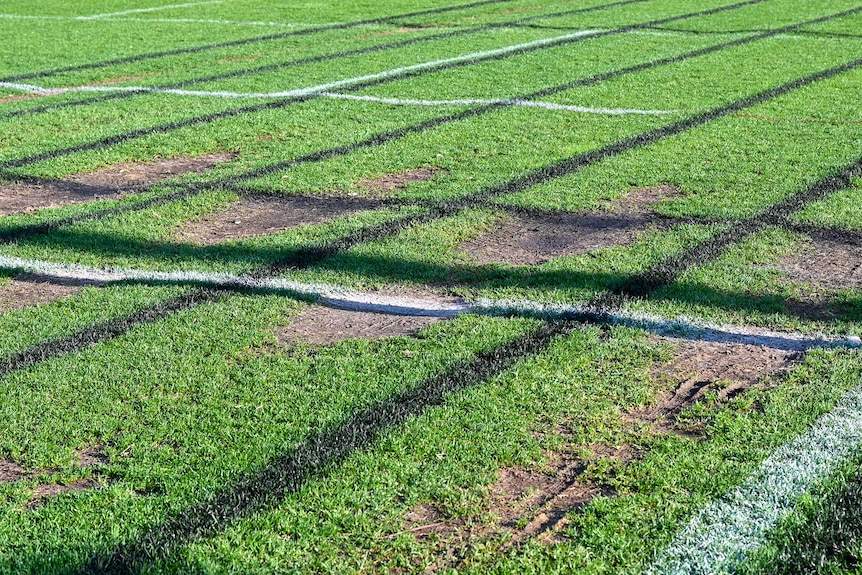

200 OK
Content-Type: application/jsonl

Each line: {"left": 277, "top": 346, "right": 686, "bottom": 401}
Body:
{"left": 0, "top": 0, "right": 862, "bottom": 243}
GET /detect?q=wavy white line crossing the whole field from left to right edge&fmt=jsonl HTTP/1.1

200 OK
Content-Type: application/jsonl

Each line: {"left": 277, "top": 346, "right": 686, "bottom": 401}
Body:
{"left": 0, "top": 256, "right": 862, "bottom": 351}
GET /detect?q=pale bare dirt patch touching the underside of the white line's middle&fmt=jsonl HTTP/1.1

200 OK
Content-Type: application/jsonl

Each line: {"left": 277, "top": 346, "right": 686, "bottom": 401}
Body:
{"left": 276, "top": 306, "right": 440, "bottom": 346}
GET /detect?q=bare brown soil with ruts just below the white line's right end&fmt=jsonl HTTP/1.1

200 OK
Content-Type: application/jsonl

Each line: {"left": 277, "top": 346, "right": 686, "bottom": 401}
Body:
{"left": 626, "top": 338, "right": 800, "bottom": 437}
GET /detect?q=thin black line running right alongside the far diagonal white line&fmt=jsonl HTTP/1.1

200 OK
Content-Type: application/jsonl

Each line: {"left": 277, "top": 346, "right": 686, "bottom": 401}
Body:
{"left": 0, "top": 0, "right": 776, "bottom": 173}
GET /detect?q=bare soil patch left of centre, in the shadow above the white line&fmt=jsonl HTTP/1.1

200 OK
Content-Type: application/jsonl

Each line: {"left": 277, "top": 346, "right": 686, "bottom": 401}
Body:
{"left": 177, "top": 196, "right": 382, "bottom": 245}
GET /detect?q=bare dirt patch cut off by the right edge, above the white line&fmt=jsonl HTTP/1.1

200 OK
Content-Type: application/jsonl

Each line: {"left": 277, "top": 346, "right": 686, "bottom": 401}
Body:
{"left": 778, "top": 237, "right": 862, "bottom": 290}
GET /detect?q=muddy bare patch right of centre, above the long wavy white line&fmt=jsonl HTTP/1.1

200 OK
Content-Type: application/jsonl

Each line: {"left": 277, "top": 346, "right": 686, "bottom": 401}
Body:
{"left": 461, "top": 186, "right": 678, "bottom": 265}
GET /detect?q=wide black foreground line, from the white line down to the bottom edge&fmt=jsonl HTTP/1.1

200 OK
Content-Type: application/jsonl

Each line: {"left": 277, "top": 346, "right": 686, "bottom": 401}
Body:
{"left": 75, "top": 321, "right": 580, "bottom": 573}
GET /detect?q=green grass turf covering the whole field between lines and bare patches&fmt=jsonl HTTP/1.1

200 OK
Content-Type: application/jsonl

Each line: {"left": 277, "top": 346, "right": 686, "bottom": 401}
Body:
{"left": 0, "top": 0, "right": 862, "bottom": 574}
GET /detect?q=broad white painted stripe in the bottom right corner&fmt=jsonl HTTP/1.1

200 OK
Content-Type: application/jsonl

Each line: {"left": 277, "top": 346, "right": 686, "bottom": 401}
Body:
{"left": 647, "top": 380, "right": 862, "bottom": 575}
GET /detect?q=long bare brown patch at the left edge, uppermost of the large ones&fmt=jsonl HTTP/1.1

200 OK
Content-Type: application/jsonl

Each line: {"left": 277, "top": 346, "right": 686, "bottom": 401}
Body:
{"left": 0, "top": 153, "right": 235, "bottom": 215}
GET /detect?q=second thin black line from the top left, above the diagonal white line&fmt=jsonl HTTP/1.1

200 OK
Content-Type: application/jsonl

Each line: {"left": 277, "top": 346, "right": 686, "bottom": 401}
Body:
{"left": 0, "top": 0, "right": 651, "bottom": 120}
